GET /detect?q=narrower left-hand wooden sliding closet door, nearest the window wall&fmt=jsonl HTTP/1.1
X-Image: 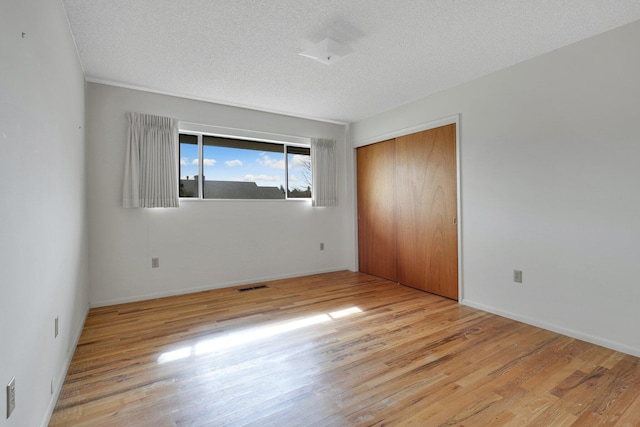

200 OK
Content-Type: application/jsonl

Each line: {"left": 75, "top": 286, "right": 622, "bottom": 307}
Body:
{"left": 356, "top": 140, "right": 397, "bottom": 281}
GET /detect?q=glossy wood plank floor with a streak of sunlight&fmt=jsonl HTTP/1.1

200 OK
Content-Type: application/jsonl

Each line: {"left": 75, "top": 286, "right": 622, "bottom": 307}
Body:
{"left": 49, "top": 272, "right": 640, "bottom": 427}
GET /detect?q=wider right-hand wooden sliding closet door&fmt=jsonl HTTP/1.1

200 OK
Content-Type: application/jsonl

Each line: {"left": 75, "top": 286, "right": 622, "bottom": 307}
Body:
{"left": 395, "top": 124, "right": 458, "bottom": 300}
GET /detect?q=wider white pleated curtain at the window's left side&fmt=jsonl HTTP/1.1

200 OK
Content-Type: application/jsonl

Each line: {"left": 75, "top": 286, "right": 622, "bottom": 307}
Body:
{"left": 123, "top": 113, "right": 180, "bottom": 208}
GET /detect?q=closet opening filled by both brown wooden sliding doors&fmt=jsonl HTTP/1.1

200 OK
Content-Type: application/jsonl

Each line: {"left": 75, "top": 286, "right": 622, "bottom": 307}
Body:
{"left": 356, "top": 124, "right": 458, "bottom": 300}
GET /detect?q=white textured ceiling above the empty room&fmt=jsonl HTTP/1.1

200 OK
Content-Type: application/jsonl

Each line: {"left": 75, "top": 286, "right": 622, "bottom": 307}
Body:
{"left": 62, "top": 0, "right": 640, "bottom": 123}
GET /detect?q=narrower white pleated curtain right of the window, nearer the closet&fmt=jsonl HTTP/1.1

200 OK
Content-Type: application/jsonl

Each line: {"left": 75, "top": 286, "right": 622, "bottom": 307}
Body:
{"left": 311, "top": 138, "right": 338, "bottom": 206}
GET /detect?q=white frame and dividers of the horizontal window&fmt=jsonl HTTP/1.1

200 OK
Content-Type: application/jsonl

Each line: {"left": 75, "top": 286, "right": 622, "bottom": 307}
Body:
{"left": 177, "top": 122, "right": 313, "bottom": 202}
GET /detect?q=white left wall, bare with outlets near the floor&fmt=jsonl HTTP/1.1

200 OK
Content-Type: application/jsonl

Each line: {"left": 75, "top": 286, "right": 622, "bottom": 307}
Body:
{"left": 0, "top": 0, "right": 89, "bottom": 427}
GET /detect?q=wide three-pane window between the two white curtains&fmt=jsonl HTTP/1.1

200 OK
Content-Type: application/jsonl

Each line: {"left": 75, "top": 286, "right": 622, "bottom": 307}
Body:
{"left": 180, "top": 132, "right": 311, "bottom": 199}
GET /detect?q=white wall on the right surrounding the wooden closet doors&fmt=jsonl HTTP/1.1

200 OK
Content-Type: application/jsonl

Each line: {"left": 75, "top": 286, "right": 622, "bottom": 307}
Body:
{"left": 349, "top": 22, "right": 640, "bottom": 356}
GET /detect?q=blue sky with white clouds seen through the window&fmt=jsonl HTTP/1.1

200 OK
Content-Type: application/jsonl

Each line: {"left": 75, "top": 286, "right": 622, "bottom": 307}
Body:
{"left": 180, "top": 144, "right": 310, "bottom": 189}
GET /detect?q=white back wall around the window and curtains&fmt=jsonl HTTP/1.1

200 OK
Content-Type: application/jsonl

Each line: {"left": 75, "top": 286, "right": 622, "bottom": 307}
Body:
{"left": 87, "top": 83, "right": 355, "bottom": 305}
